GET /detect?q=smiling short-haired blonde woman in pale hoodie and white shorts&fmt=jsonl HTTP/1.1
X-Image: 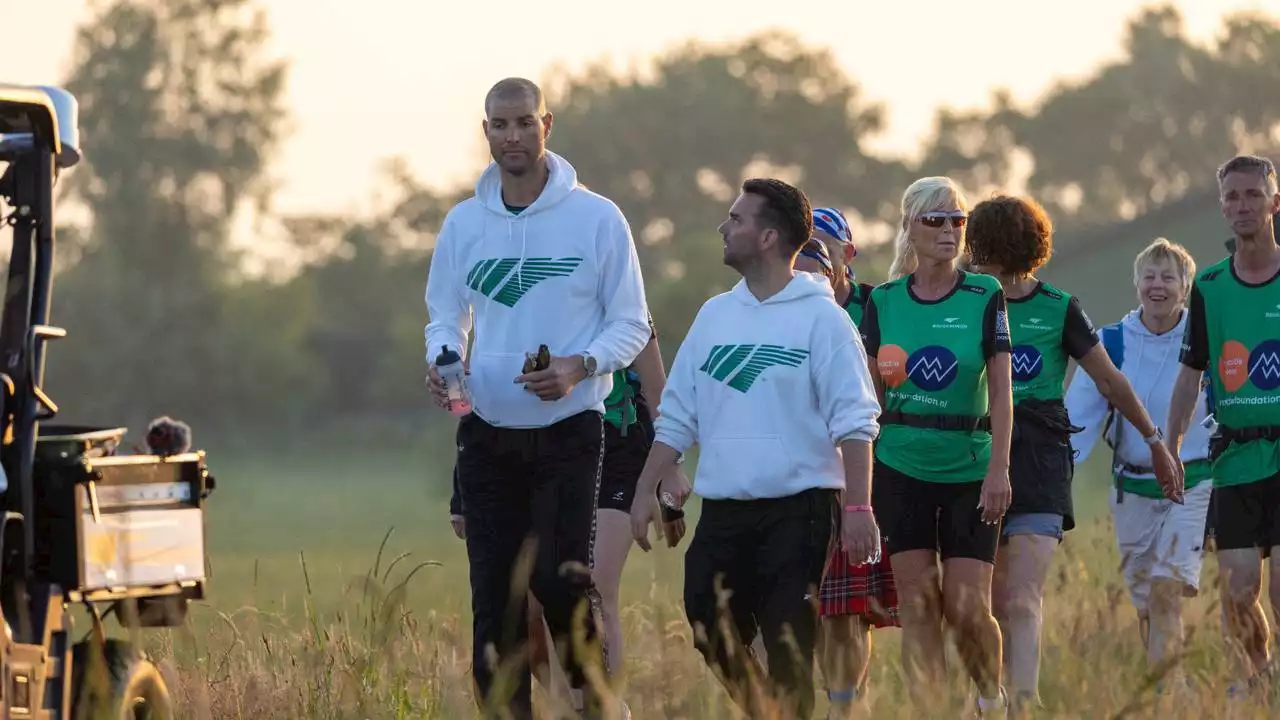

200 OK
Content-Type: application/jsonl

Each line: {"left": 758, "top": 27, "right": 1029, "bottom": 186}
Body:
{"left": 1066, "top": 238, "right": 1213, "bottom": 681}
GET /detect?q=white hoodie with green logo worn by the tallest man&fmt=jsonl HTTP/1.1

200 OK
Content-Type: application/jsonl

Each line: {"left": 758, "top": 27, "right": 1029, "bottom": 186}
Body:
{"left": 425, "top": 152, "right": 650, "bottom": 428}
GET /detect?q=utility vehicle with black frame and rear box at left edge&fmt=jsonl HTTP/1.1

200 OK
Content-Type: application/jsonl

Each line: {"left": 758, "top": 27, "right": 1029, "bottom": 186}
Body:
{"left": 0, "top": 83, "right": 214, "bottom": 720}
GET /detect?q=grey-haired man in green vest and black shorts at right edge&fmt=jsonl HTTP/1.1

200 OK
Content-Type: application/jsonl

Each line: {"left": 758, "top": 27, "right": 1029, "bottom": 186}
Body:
{"left": 1166, "top": 155, "right": 1280, "bottom": 688}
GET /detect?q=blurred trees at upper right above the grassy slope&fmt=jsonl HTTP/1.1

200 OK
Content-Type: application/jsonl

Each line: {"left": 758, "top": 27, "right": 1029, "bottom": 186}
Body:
{"left": 923, "top": 6, "right": 1280, "bottom": 224}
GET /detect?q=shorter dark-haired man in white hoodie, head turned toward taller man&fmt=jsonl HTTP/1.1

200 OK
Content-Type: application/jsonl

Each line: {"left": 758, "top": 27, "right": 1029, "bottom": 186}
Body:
{"left": 631, "top": 179, "right": 879, "bottom": 719}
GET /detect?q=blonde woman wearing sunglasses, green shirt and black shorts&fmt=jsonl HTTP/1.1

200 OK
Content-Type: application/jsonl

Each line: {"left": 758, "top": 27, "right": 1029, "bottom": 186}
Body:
{"left": 861, "top": 177, "right": 1012, "bottom": 716}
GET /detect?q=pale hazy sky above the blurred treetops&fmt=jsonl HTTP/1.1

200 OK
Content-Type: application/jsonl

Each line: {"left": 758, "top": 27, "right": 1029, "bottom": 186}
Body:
{"left": 10, "top": 0, "right": 1280, "bottom": 217}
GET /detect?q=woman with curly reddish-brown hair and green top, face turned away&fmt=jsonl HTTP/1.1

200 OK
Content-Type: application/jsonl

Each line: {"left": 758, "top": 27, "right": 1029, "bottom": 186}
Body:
{"left": 968, "top": 195, "right": 1178, "bottom": 708}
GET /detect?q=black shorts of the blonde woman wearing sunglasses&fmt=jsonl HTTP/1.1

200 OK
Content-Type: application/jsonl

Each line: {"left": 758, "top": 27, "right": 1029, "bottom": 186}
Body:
{"left": 872, "top": 460, "right": 1000, "bottom": 564}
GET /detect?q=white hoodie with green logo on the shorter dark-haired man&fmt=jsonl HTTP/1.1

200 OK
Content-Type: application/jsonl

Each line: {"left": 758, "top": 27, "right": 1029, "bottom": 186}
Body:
{"left": 654, "top": 273, "right": 879, "bottom": 500}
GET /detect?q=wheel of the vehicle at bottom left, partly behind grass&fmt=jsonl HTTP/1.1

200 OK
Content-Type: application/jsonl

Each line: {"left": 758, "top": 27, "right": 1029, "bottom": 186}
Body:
{"left": 72, "top": 639, "right": 174, "bottom": 720}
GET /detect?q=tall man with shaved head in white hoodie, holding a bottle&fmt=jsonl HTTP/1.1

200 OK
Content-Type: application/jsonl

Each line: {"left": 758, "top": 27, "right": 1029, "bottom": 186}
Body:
{"left": 425, "top": 78, "right": 650, "bottom": 717}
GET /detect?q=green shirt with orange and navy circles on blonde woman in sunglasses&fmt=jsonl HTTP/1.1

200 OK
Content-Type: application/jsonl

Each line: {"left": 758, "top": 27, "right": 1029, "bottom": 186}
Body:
{"left": 860, "top": 272, "right": 1010, "bottom": 483}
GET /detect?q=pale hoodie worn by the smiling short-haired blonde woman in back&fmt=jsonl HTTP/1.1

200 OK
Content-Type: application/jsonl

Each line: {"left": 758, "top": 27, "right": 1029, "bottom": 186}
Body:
{"left": 1065, "top": 310, "right": 1212, "bottom": 478}
